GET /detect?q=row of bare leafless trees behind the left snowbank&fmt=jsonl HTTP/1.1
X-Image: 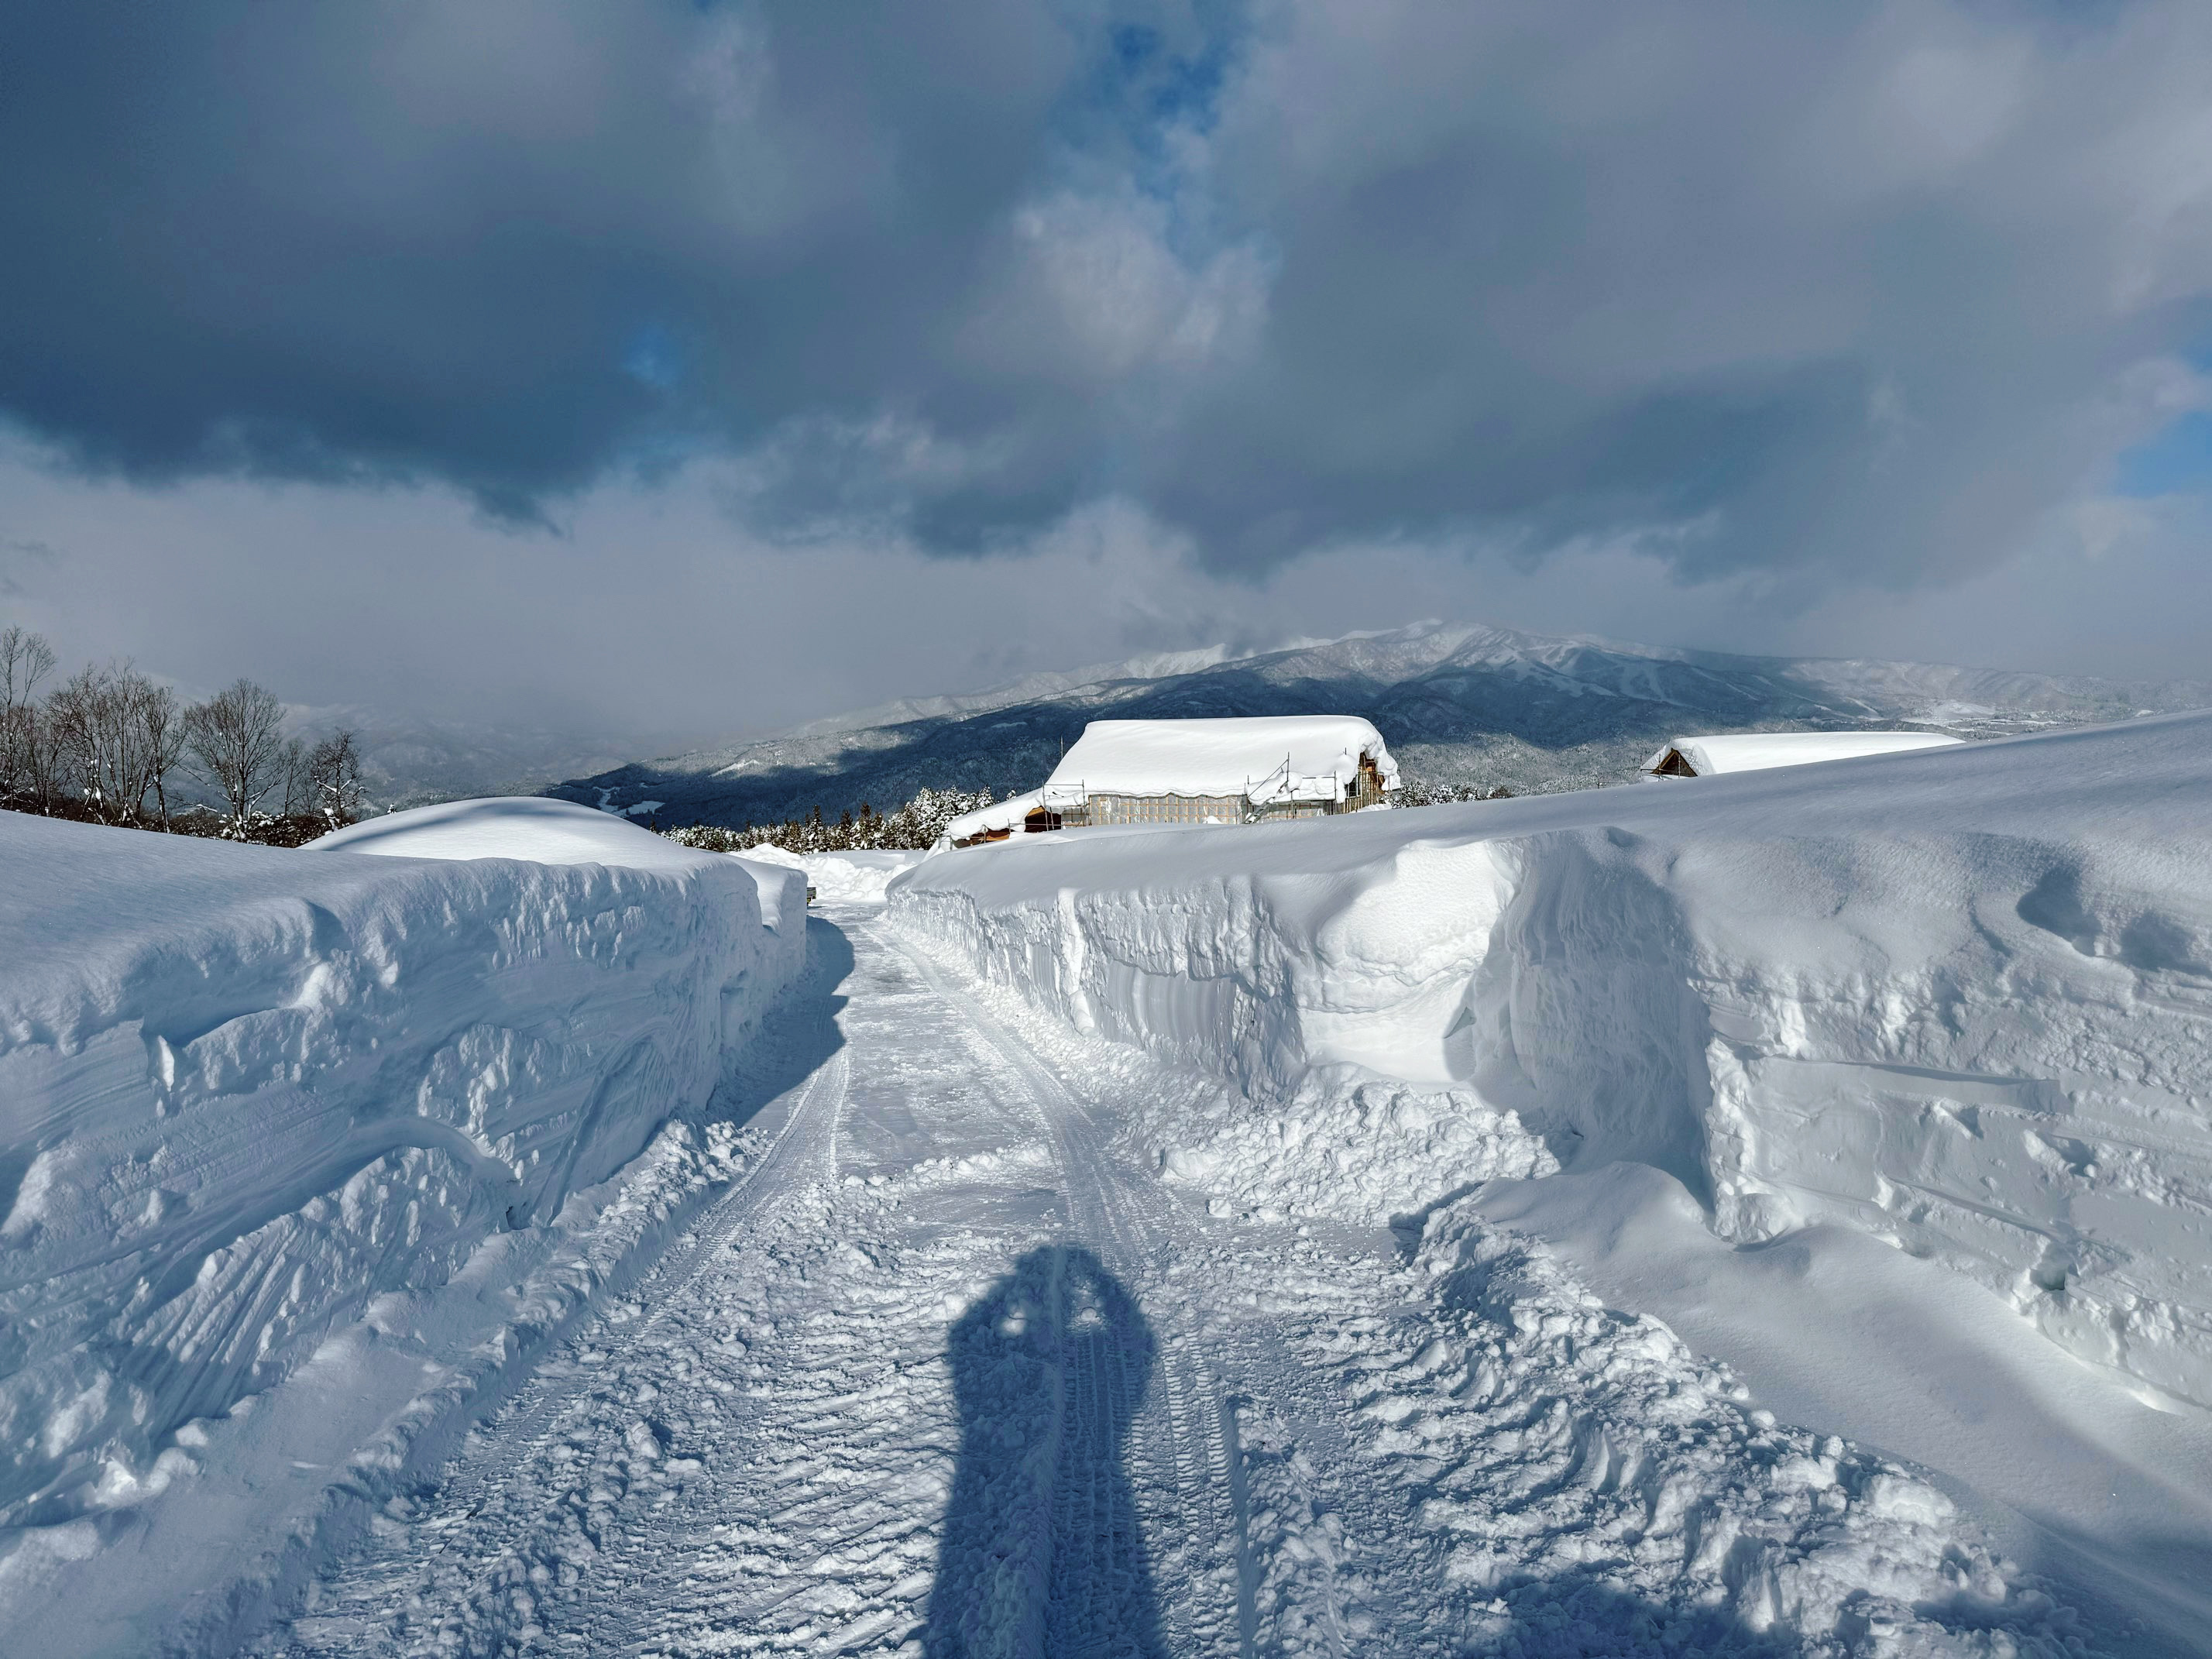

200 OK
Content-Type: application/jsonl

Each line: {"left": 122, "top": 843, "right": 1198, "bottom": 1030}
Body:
{"left": 0, "top": 626, "right": 362, "bottom": 845}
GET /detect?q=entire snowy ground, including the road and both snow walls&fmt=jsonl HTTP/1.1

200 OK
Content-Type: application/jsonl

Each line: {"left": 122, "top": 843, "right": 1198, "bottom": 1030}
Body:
{"left": 0, "top": 714, "right": 2212, "bottom": 1657}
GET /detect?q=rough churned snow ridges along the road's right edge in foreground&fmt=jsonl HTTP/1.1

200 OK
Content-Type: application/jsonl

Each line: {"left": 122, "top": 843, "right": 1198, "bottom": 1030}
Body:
{"left": 1347, "top": 1206, "right": 2081, "bottom": 1657}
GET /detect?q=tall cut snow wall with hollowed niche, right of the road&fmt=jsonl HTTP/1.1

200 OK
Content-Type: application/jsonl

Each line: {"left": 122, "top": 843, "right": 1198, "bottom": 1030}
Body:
{"left": 889, "top": 714, "right": 2212, "bottom": 1405}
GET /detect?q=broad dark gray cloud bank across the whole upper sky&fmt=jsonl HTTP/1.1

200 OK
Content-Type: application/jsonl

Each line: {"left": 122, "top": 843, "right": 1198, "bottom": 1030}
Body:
{"left": 0, "top": 0, "right": 2212, "bottom": 592}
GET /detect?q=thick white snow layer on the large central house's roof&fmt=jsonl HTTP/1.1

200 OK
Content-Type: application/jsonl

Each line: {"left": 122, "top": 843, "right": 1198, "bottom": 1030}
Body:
{"left": 1044, "top": 714, "right": 1398, "bottom": 803}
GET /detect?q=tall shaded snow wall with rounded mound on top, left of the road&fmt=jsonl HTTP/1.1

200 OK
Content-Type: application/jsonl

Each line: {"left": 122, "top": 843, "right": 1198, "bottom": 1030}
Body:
{"left": 0, "top": 801, "right": 805, "bottom": 1650}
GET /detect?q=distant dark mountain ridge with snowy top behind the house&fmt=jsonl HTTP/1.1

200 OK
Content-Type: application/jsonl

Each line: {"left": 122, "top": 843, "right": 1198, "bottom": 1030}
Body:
{"left": 546, "top": 622, "right": 2212, "bottom": 827}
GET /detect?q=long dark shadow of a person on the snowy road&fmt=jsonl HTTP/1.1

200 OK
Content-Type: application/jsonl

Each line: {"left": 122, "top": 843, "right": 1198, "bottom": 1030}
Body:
{"left": 922, "top": 1245, "right": 1166, "bottom": 1659}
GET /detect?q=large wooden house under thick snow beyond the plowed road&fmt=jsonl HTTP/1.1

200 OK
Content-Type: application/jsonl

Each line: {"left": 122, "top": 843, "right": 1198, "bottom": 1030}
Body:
{"left": 945, "top": 714, "right": 1398, "bottom": 847}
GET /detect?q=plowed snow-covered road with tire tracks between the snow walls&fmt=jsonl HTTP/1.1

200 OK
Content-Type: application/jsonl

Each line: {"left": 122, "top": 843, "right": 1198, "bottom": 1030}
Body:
{"left": 252, "top": 907, "right": 2075, "bottom": 1657}
